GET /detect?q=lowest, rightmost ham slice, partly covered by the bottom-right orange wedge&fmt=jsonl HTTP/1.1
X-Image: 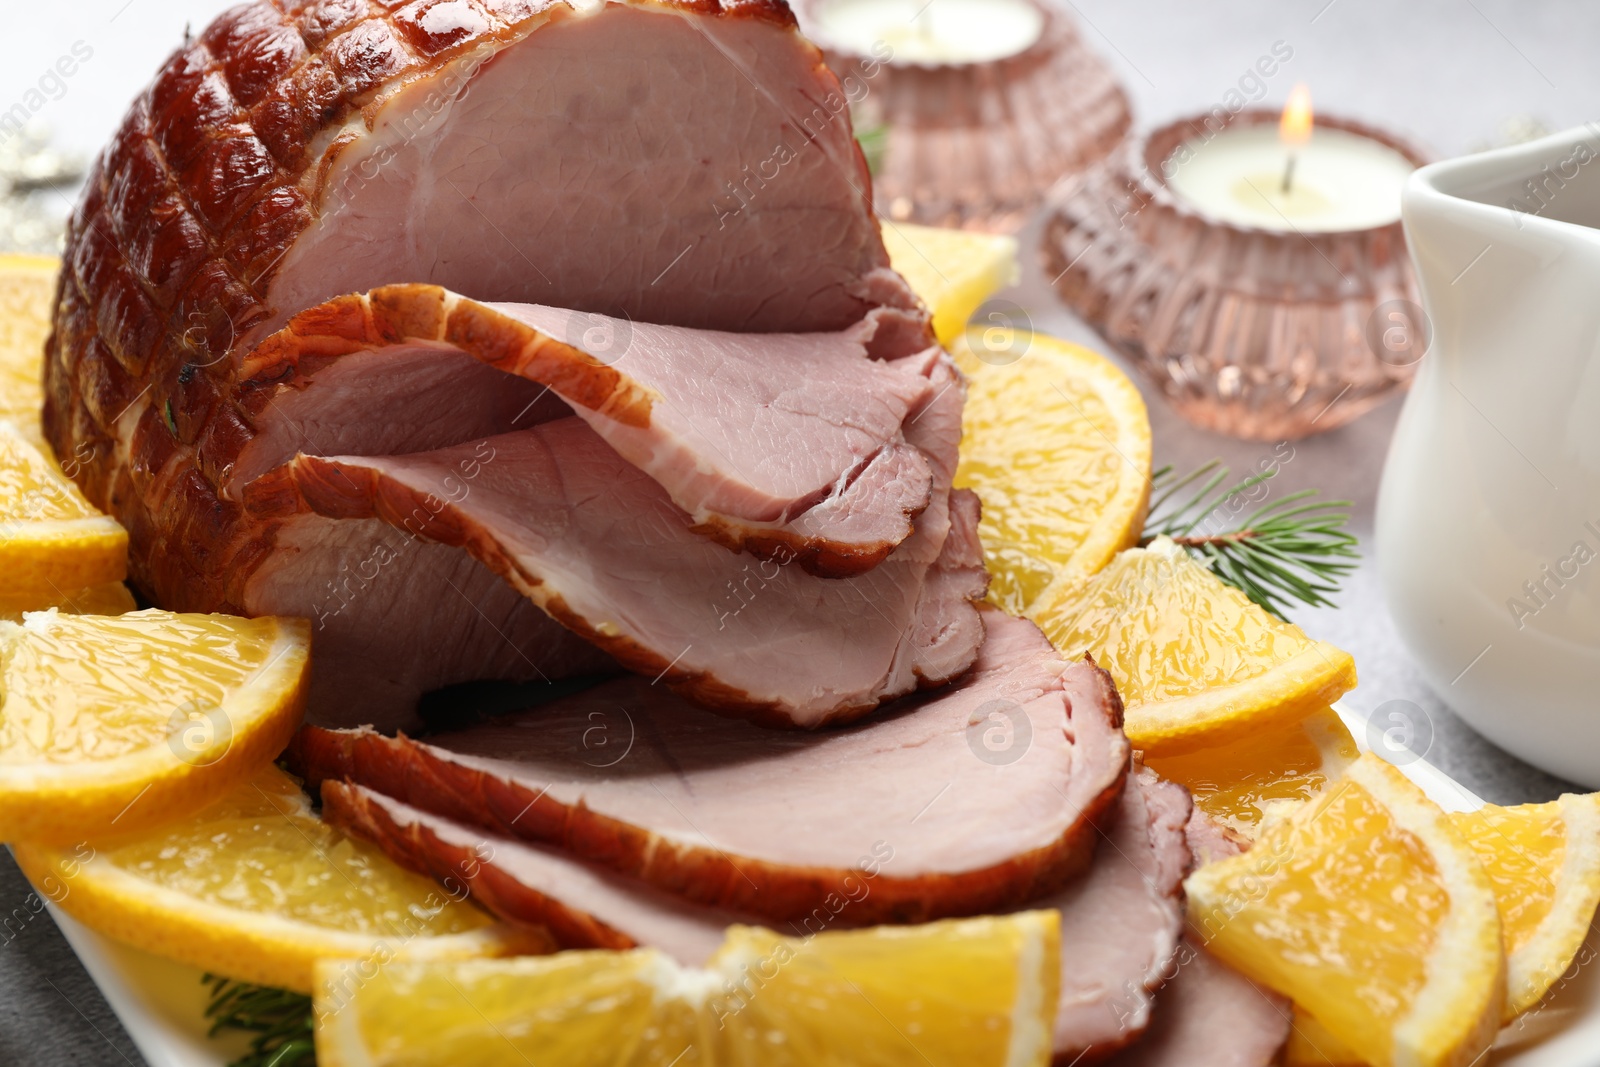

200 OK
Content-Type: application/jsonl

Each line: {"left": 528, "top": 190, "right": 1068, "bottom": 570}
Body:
{"left": 1110, "top": 809, "right": 1293, "bottom": 1067}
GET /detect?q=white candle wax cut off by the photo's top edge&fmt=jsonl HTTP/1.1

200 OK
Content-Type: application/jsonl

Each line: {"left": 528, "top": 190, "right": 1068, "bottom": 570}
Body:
{"left": 814, "top": 0, "right": 1045, "bottom": 64}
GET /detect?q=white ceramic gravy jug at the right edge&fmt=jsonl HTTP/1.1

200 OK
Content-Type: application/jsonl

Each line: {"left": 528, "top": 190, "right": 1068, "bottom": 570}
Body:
{"left": 1378, "top": 123, "right": 1600, "bottom": 787}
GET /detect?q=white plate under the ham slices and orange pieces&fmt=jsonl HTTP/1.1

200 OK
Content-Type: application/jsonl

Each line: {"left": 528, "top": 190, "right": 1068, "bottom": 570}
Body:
{"left": 31, "top": 707, "right": 1600, "bottom": 1067}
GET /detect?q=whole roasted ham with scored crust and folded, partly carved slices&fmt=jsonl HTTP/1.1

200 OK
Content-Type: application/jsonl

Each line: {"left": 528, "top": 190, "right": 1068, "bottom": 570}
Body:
{"left": 45, "top": 0, "right": 984, "bottom": 726}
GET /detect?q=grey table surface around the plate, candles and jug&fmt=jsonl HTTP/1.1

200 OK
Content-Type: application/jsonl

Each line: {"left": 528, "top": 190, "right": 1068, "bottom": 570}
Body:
{"left": 0, "top": 0, "right": 1600, "bottom": 1067}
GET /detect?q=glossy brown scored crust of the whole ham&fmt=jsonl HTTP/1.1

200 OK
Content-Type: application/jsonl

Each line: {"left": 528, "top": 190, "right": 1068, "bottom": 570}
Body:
{"left": 45, "top": 0, "right": 888, "bottom": 611}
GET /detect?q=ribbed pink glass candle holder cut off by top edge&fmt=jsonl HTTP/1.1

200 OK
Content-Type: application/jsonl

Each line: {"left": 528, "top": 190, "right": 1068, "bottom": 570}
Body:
{"left": 797, "top": 0, "right": 1131, "bottom": 232}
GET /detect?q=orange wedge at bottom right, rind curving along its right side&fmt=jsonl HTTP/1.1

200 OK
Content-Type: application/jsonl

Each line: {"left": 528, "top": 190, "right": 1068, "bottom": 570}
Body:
{"left": 1186, "top": 753, "right": 1506, "bottom": 1067}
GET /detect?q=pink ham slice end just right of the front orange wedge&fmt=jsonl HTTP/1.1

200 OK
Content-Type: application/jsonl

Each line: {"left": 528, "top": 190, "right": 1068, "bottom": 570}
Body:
{"left": 1029, "top": 769, "right": 1192, "bottom": 1064}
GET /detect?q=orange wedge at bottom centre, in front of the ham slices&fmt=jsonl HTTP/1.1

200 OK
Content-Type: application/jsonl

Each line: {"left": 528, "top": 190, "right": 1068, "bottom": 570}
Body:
{"left": 315, "top": 912, "right": 1061, "bottom": 1067}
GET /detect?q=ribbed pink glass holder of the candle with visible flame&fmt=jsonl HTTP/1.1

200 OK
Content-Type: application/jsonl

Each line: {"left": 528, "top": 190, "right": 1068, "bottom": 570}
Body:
{"left": 1042, "top": 110, "right": 1430, "bottom": 440}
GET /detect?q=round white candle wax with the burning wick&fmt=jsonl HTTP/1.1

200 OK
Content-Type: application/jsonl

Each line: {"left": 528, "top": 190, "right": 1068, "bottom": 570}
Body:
{"left": 1165, "top": 123, "right": 1414, "bottom": 234}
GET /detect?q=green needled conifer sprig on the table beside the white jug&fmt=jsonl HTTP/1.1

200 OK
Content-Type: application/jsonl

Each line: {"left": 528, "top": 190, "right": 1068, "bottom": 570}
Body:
{"left": 1139, "top": 459, "right": 1360, "bottom": 619}
